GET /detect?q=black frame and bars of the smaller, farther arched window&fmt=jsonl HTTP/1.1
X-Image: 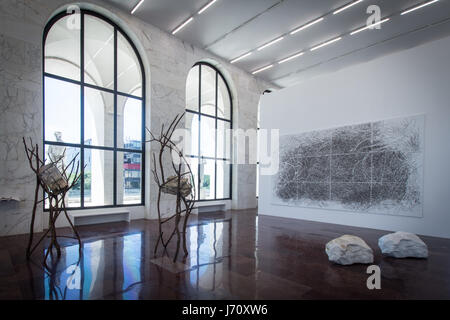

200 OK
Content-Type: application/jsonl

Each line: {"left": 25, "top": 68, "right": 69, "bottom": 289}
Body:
{"left": 186, "top": 61, "right": 233, "bottom": 202}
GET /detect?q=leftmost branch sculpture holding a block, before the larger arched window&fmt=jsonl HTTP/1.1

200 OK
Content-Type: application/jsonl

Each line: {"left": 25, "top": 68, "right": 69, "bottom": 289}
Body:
{"left": 22, "top": 138, "right": 82, "bottom": 266}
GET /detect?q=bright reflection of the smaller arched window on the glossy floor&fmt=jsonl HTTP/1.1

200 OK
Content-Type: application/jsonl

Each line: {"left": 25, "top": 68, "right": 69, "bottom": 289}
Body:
{"left": 188, "top": 219, "right": 231, "bottom": 290}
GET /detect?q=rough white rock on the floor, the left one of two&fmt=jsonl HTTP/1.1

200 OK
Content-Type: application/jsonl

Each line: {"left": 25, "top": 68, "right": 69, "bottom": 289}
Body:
{"left": 325, "top": 235, "right": 373, "bottom": 265}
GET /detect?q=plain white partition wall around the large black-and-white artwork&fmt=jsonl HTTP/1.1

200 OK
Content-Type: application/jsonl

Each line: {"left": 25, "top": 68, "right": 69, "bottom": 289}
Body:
{"left": 258, "top": 37, "right": 450, "bottom": 238}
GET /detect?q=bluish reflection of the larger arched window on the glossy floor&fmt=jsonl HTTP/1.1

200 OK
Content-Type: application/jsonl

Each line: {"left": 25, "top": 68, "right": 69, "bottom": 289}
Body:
{"left": 44, "top": 233, "right": 142, "bottom": 300}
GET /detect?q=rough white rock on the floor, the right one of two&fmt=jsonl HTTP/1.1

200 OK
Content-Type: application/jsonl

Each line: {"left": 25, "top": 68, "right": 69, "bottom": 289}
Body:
{"left": 378, "top": 231, "right": 428, "bottom": 258}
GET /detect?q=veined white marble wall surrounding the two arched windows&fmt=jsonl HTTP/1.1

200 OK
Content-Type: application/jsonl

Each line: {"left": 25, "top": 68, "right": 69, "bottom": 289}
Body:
{"left": 0, "top": 0, "right": 274, "bottom": 235}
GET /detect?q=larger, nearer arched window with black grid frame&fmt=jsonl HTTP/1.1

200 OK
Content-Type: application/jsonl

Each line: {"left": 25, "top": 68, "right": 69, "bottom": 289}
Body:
{"left": 44, "top": 10, "right": 145, "bottom": 208}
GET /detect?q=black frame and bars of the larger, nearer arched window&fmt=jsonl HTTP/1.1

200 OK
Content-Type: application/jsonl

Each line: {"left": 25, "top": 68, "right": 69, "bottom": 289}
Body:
{"left": 42, "top": 9, "right": 146, "bottom": 212}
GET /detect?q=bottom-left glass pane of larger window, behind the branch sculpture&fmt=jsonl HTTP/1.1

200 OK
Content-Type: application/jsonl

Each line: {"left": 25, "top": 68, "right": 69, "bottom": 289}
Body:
{"left": 44, "top": 144, "right": 81, "bottom": 209}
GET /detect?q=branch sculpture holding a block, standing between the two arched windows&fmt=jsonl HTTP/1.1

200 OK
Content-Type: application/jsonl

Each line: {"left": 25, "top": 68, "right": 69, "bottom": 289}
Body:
{"left": 147, "top": 113, "right": 195, "bottom": 262}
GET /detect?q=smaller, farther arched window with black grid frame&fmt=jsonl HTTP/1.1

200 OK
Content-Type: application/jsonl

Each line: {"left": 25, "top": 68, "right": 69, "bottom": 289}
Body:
{"left": 185, "top": 62, "right": 233, "bottom": 201}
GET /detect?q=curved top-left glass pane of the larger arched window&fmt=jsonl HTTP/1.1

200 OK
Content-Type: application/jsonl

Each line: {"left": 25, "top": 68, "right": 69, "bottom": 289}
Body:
{"left": 45, "top": 14, "right": 80, "bottom": 80}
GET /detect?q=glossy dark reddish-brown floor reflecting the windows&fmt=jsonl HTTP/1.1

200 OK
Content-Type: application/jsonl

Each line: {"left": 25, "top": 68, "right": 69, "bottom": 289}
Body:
{"left": 0, "top": 210, "right": 450, "bottom": 299}
